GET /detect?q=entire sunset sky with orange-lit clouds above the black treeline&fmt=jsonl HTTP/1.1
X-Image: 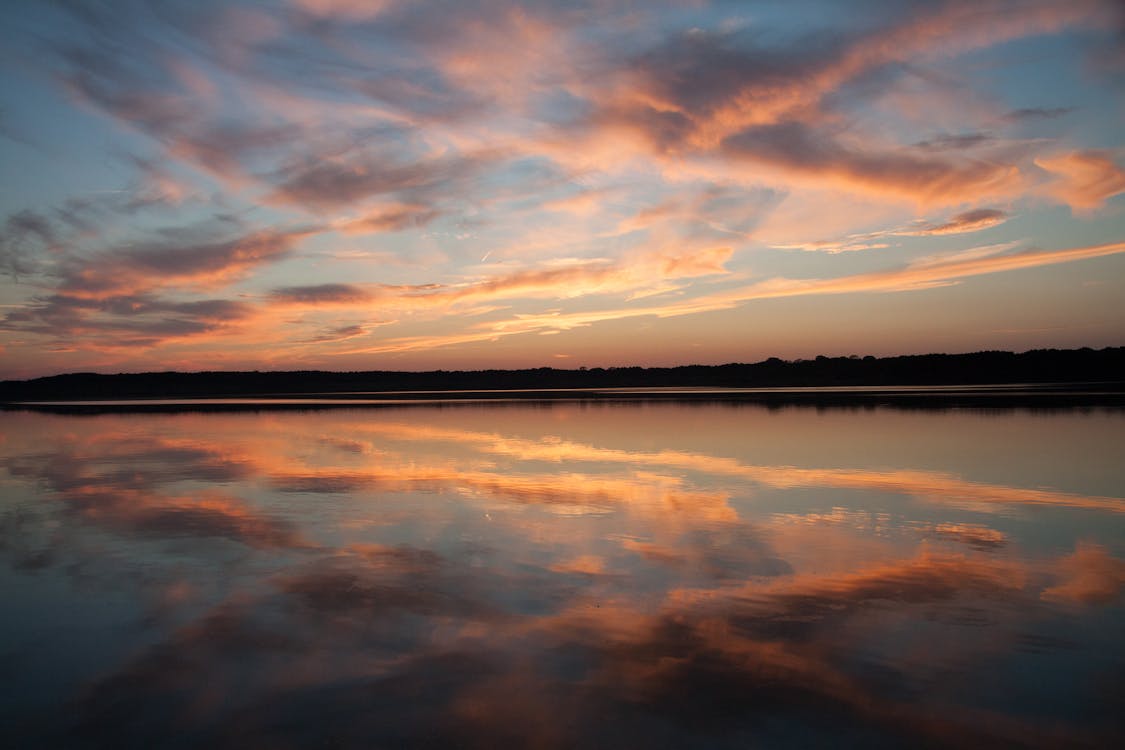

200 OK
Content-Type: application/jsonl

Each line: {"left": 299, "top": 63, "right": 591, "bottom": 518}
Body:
{"left": 0, "top": 0, "right": 1125, "bottom": 378}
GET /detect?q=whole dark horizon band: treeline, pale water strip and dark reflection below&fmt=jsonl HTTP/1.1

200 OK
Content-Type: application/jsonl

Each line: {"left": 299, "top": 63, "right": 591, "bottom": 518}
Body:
{"left": 0, "top": 346, "right": 1125, "bottom": 408}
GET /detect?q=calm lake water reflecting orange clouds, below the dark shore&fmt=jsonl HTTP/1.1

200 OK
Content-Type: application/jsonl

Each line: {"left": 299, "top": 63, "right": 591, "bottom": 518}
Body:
{"left": 0, "top": 403, "right": 1125, "bottom": 748}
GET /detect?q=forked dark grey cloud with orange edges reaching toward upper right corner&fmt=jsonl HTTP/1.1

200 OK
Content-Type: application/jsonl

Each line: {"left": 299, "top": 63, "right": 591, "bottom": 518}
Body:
{"left": 576, "top": 2, "right": 1110, "bottom": 168}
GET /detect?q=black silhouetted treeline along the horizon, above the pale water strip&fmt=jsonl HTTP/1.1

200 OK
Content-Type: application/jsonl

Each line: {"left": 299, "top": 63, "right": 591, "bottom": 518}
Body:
{"left": 0, "top": 346, "right": 1125, "bottom": 403}
